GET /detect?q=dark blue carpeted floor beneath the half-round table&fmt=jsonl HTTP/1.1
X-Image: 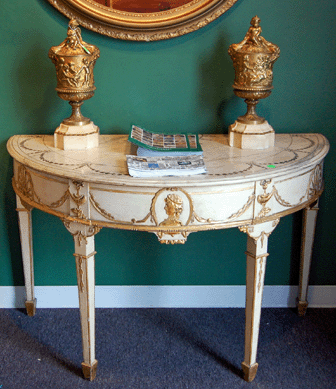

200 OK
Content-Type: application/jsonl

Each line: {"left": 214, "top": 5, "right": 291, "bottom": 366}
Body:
{"left": 0, "top": 308, "right": 336, "bottom": 389}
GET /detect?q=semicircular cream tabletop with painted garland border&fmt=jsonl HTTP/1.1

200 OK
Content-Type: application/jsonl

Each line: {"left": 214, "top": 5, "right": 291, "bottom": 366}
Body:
{"left": 7, "top": 134, "right": 329, "bottom": 186}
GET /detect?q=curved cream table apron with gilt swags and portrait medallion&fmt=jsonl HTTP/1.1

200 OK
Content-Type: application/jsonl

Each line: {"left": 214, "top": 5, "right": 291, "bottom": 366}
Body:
{"left": 13, "top": 161, "right": 323, "bottom": 236}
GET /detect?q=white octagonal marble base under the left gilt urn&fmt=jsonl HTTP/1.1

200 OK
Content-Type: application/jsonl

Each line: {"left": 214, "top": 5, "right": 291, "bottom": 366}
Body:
{"left": 54, "top": 122, "right": 99, "bottom": 150}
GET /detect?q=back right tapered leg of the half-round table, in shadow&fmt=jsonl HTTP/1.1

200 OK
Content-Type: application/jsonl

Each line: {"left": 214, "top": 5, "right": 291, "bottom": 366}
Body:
{"left": 297, "top": 201, "right": 318, "bottom": 316}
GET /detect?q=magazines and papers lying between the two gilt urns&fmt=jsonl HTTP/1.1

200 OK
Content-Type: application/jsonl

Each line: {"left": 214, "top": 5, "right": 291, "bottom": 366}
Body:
{"left": 126, "top": 126, "right": 207, "bottom": 177}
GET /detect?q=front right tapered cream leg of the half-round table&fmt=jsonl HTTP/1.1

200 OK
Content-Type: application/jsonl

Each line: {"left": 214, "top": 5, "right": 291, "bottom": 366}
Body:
{"left": 240, "top": 220, "right": 279, "bottom": 382}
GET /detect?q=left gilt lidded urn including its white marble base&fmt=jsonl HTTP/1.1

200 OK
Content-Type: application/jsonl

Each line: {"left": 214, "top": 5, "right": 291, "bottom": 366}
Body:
{"left": 49, "top": 19, "right": 99, "bottom": 149}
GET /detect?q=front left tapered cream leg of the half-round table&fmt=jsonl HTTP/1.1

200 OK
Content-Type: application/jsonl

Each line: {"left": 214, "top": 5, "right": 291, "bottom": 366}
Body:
{"left": 64, "top": 222, "right": 99, "bottom": 381}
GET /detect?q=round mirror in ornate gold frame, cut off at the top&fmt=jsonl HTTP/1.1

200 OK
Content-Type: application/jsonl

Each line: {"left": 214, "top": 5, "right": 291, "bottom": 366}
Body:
{"left": 48, "top": 0, "right": 238, "bottom": 41}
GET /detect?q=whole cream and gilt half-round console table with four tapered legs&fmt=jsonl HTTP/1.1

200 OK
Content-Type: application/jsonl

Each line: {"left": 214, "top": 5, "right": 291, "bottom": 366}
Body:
{"left": 7, "top": 134, "right": 329, "bottom": 381}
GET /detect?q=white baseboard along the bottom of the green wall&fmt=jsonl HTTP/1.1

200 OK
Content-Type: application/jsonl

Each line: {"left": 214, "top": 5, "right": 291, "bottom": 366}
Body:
{"left": 0, "top": 285, "right": 336, "bottom": 308}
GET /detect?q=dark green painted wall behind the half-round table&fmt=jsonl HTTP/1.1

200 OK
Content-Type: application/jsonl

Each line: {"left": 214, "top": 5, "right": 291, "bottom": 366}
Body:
{"left": 0, "top": 0, "right": 336, "bottom": 285}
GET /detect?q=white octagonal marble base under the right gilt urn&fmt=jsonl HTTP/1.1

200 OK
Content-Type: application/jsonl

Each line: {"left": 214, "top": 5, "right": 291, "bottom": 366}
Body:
{"left": 229, "top": 120, "right": 275, "bottom": 150}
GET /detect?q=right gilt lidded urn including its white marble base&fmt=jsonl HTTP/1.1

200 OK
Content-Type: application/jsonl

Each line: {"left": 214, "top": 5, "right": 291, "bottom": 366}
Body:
{"left": 229, "top": 16, "right": 280, "bottom": 149}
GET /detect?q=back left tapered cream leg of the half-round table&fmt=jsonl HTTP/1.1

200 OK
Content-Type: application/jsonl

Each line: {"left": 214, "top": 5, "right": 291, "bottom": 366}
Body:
{"left": 16, "top": 195, "right": 36, "bottom": 316}
